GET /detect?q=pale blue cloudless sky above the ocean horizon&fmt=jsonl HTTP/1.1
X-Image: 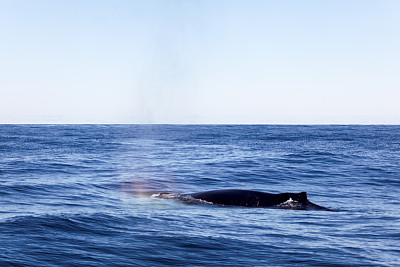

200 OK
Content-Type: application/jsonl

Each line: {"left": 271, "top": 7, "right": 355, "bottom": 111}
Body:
{"left": 0, "top": 0, "right": 400, "bottom": 124}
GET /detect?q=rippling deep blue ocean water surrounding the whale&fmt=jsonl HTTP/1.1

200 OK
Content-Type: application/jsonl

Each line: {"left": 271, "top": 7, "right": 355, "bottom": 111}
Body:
{"left": 0, "top": 125, "right": 400, "bottom": 266}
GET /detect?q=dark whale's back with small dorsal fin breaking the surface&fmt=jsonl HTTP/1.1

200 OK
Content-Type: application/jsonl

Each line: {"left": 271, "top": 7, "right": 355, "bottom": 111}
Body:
{"left": 180, "top": 189, "right": 335, "bottom": 211}
